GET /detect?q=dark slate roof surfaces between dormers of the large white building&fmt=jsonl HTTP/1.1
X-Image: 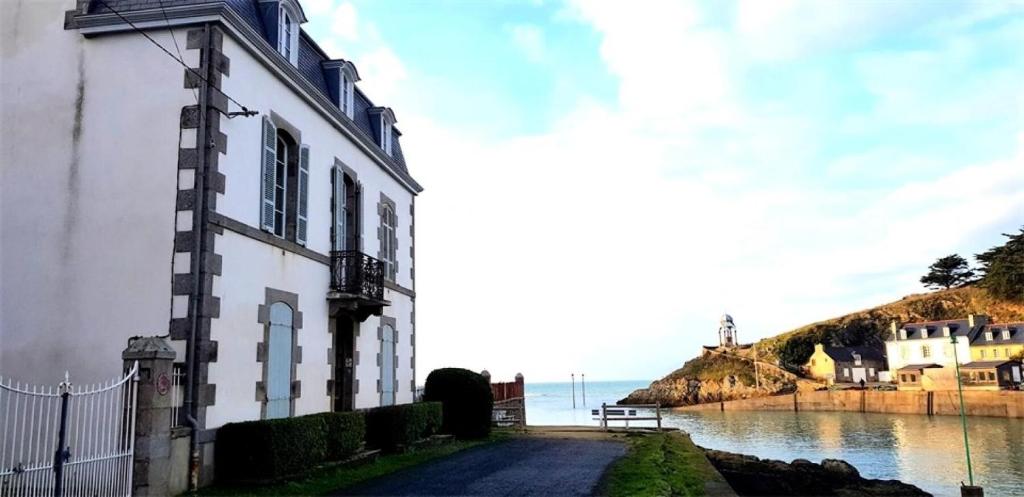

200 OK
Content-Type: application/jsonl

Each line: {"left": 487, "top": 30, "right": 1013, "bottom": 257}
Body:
{"left": 78, "top": 0, "right": 409, "bottom": 173}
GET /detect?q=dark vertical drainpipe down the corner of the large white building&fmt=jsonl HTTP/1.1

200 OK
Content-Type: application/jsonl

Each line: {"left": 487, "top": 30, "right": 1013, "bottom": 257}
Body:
{"left": 182, "top": 24, "right": 212, "bottom": 491}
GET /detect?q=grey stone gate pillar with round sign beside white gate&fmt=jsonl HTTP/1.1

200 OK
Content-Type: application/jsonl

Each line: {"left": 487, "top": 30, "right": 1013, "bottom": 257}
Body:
{"left": 121, "top": 336, "right": 175, "bottom": 496}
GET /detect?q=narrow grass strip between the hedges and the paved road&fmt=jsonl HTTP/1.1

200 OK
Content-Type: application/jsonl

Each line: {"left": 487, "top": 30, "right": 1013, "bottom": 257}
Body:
{"left": 194, "top": 431, "right": 510, "bottom": 496}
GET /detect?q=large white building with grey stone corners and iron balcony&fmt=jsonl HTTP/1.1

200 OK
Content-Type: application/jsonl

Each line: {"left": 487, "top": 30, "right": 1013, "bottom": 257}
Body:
{"left": 0, "top": 0, "right": 422, "bottom": 479}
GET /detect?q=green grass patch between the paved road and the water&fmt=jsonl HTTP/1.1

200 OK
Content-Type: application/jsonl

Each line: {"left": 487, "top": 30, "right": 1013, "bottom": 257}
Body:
{"left": 601, "top": 432, "right": 728, "bottom": 497}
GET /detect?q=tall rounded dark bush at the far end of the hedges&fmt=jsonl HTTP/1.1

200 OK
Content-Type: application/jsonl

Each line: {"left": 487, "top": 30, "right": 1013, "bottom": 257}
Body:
{"left": 423, "top": 368, "right": 495, "bottom": 439}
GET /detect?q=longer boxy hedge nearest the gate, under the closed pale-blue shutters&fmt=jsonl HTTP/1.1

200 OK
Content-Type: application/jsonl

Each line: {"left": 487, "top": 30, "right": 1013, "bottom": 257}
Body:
{"left": 215, "top": 412, "right": 367, "bottom": 483}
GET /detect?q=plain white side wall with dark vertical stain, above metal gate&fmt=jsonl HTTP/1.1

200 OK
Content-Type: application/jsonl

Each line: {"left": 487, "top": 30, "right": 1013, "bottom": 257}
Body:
{"left": 0, "top": 0, "right": 195, "bottom": 383}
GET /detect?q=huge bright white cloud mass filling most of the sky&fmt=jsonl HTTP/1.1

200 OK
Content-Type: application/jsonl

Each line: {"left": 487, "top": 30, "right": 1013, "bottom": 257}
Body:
{"left": 303, "top": 0, "right": 1024, "bottom": 380}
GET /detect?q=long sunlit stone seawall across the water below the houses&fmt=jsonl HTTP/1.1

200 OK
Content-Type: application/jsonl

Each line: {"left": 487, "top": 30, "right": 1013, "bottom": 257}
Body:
{"left": 675, "top": 390, "right": 1024, "bottom": 418}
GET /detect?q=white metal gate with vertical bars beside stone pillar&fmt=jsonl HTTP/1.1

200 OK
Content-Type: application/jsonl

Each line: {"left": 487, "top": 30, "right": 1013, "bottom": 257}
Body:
{"left": 0, "top": 363, "right": 138, "bottom": 497}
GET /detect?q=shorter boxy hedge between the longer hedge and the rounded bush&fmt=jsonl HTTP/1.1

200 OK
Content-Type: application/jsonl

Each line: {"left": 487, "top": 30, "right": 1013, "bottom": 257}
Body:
{"left": 366, "top": 402, "right": 442, "bottom": 452}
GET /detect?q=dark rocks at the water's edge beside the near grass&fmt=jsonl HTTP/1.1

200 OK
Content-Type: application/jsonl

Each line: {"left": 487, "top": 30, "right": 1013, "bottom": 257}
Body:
{"left": 705, "top": 449, "right": 932, "bottom": 497}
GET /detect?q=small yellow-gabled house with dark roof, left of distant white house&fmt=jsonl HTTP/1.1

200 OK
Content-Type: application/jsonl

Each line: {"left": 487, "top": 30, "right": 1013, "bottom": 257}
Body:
{"left": 804, "top": 343, "right": 886, "bottom": 383}
